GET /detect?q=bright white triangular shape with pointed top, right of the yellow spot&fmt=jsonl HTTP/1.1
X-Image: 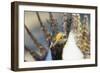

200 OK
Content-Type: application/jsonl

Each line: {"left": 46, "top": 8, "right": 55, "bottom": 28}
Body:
{"left": 62, "top": 31, "right": 83, "bottom": 60}
